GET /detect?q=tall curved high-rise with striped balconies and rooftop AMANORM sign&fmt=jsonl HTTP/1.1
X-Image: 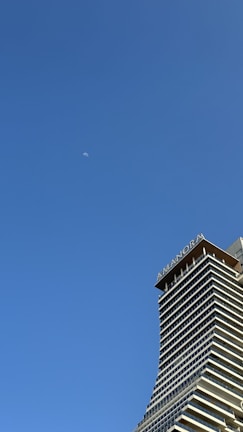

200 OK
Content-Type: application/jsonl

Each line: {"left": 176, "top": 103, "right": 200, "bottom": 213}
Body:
{"left": 135, "top": 234, "right": 243, "bottom": 432}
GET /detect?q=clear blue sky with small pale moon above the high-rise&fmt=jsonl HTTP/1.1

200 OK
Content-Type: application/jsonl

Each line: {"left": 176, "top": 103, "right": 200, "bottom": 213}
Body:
{"left": 0, "top": 0, "right": 243, "bottom": 432}
